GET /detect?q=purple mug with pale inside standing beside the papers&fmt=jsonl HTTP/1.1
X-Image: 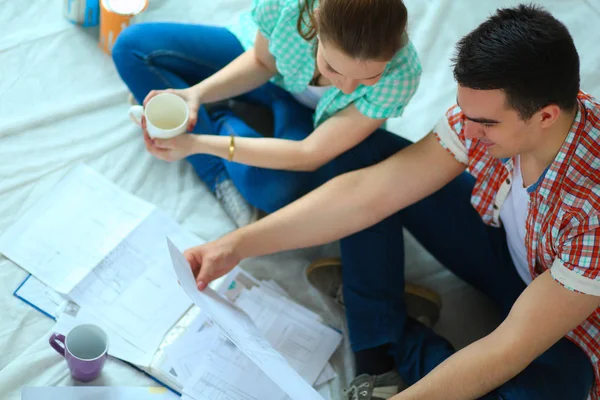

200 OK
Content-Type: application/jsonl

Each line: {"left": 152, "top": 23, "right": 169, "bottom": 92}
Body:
{"left": 49, "top": 324, "right": 108, "bottom": 382}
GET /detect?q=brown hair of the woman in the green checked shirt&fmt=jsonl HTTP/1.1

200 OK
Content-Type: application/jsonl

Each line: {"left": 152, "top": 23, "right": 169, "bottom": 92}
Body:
{"left": 297, "top": 0, "right": 408, "bottom": 60}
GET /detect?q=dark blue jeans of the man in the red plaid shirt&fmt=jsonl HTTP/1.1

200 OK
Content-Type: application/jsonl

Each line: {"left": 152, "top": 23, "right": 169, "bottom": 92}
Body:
{"left": 342, "top": 136, "right": 594, "bottom": 400}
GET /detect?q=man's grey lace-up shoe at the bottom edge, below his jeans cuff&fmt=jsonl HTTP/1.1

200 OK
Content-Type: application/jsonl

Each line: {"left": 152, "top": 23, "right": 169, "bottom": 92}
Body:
{"left": 344, "top": 371, "right": 404, "bottom": 400}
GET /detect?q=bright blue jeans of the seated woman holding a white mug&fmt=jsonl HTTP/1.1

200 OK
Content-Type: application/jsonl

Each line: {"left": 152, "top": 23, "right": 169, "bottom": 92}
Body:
{"left": 113, "top": 23, "right": 404, "bottom": 212}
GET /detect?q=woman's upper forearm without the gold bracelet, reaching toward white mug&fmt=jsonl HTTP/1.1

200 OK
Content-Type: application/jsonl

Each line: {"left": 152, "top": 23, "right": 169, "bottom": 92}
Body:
{"left": 189, "top": 32, "right": 277, "bottom": 104}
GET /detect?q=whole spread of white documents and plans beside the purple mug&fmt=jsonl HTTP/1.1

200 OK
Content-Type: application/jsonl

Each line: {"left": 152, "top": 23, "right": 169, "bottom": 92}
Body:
{"left": 0, "top": 165, "right": 341, "bottom": 400}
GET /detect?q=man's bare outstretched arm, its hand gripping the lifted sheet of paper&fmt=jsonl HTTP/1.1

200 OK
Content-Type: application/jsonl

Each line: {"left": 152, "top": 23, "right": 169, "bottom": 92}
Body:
{"left": 185, "top": 134, "right": 465, "bottom": 290}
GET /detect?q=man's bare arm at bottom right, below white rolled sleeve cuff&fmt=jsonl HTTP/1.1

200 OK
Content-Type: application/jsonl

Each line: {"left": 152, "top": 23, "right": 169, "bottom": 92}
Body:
{"left": 392, "top": 271, "right": 600, "bottom": 400}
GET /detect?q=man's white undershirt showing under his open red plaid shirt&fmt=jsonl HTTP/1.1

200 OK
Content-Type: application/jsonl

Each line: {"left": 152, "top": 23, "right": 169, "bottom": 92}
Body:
{"left": 500, "top": 156, "right": 532, "bottom": 285}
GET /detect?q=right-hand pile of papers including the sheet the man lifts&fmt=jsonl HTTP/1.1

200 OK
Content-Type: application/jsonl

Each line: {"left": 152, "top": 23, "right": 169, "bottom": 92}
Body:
{"left": 165, "top": 244, "right": 341, "bottom": 400}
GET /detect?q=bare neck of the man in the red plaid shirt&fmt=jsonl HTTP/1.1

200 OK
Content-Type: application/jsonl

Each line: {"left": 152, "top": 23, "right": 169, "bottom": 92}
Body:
{"left": 521, "top": 108, "right": 577, "bottom": 186}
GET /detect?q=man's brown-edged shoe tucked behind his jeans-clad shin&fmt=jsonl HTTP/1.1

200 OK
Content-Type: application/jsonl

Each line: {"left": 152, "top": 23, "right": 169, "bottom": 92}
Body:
{"left": 306, "top": 258, "right": 442, "bottom": 327}
